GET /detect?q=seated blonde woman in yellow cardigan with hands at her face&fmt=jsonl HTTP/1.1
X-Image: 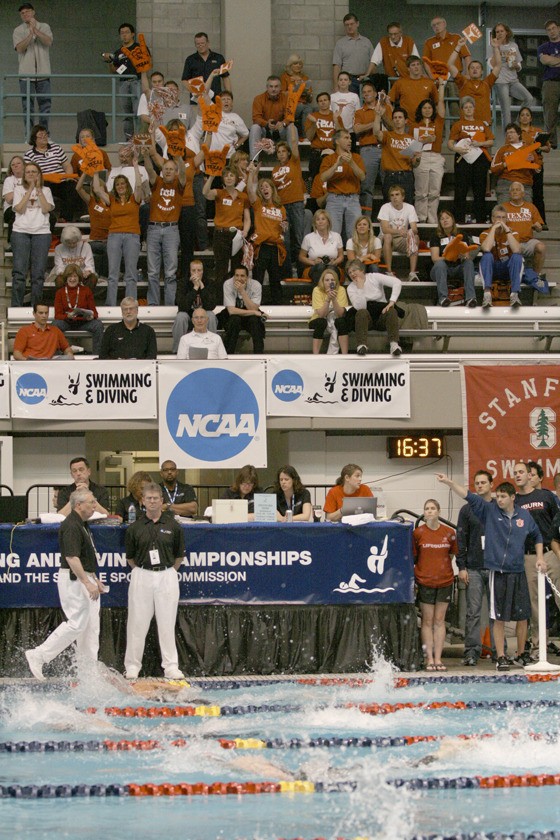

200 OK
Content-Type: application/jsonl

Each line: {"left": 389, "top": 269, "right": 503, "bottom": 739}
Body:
{"left": 309, "top": 268, "right": 349, "bottom": 355}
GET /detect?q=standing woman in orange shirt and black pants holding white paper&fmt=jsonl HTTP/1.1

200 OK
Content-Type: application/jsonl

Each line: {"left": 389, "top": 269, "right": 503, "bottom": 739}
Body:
{"left": 447, "top": 96, "right": 494, "bottom": 225}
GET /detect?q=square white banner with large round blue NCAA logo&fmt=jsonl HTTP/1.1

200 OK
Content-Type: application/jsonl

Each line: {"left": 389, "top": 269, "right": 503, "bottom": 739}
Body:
{"left": 159, "top": 360, "right": 266, "bottom": 468}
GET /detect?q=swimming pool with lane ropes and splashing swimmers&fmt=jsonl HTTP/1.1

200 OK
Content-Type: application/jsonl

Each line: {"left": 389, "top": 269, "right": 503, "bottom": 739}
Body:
{"left": 0, "top": 663, "right": 560, "bottom": 840}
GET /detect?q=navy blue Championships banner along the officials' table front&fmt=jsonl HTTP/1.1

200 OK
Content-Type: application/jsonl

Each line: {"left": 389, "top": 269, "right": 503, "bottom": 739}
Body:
{"left": 0, "top": 522, "right": 414, "bottom": 609}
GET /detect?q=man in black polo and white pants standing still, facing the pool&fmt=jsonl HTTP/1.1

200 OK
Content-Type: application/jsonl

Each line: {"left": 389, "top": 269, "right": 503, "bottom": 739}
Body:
{"left": 124, "top": 484, "right": 185, "bottom": 680}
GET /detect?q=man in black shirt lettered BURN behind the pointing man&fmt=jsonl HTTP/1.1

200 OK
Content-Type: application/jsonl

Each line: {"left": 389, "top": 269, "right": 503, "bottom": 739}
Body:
{"left": 513, "top": 463, "right": 560, "bottom": 652}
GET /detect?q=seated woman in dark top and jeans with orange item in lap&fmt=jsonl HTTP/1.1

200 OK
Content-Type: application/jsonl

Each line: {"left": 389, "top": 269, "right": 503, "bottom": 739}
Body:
{"left": 430, "top": 210, "right": 477, "bottom": 309}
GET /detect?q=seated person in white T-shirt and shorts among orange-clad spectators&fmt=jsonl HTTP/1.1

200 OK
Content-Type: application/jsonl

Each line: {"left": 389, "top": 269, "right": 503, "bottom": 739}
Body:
{"left": 377, "top": 184, "right": 419, "bottom": 281}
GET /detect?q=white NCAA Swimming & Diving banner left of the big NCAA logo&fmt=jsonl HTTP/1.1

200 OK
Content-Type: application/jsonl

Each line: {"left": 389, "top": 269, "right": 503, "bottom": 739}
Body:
{"left": 10, "top": 359, "right": 157, "bottom": 420}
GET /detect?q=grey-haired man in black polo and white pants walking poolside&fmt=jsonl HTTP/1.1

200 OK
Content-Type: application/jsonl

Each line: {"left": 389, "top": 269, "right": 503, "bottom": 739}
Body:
{"left": 25, "top": 489, "right": 104, "bottom": 680}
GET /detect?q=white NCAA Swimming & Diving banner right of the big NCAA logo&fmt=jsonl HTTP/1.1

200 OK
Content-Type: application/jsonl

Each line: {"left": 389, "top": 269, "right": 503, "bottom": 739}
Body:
{"left": 266, "top": 356, "right": 410, "bottom": 418}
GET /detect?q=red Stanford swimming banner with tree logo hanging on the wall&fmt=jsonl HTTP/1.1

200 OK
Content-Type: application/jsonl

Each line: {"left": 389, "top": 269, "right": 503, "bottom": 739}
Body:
{"left": 462, "top": 365, "right": 560, "bottom": 484}
